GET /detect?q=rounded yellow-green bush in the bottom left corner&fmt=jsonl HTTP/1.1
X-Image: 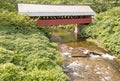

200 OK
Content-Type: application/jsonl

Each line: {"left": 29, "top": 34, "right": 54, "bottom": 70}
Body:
{"left": 0, "top": 63, "right": 25, "bottom": 81}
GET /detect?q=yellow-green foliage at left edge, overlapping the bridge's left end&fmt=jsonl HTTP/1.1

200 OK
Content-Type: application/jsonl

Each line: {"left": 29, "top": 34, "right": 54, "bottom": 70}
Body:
{"left": 0, "top": 9, "right": 36, "bottom": 28}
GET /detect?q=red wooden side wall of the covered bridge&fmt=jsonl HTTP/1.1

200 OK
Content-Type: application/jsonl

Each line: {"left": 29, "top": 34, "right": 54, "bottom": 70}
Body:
{"left": 37, "top": 17, "right": 92, "bottom": 26}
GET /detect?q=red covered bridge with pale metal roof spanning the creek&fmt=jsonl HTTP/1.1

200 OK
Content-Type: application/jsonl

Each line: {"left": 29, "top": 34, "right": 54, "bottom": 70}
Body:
{"left": 18, "top": 4, "right": 95, "bottom": 33}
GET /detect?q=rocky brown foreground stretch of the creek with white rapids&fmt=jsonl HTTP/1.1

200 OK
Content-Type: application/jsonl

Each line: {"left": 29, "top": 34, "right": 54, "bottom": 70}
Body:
{"left": 59, "top": 45, "right": 120, "bottom": 81}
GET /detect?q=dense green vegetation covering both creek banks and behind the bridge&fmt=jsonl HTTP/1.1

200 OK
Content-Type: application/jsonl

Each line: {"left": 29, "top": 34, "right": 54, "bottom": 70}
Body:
{"left": 0, "top": 0, "right": 120, "bottom": 81}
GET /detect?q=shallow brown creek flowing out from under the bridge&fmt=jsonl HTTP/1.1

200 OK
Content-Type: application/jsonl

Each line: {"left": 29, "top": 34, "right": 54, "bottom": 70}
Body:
{"left": 51, "top": 31, "right": 120, "bottom": 81}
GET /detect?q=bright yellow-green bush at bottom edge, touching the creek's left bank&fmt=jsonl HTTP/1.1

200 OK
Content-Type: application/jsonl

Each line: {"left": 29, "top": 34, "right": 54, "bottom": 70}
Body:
{"left": 25, "top": 67, "right": 68, "bottom": 81}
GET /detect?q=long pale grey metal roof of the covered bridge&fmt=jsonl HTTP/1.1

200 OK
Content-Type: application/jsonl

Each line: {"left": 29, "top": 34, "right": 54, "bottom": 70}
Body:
{"left": 18, "top": 4, "right": 95, "bottom": 16}
